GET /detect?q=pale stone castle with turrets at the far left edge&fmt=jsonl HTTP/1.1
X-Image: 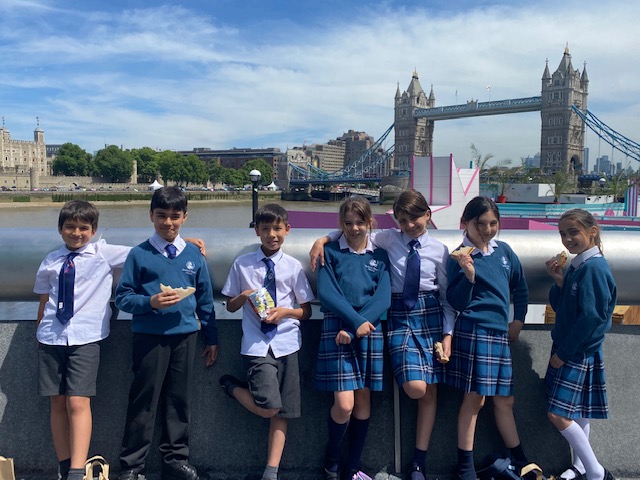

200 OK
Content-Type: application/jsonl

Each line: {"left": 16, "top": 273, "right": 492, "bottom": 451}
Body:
{"left": 0, "top": 116, "right": 50, "bottom": 190}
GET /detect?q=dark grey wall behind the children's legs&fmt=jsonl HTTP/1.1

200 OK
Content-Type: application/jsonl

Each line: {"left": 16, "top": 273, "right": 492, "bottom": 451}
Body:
{"left": 0, "top": 315, "right": 640, "bottom": 478}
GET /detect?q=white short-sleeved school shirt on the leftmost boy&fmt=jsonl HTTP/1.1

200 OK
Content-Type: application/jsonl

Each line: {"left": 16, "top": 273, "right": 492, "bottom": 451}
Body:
{"left": 33, "top": 240, "right": 131, "bottom": 345}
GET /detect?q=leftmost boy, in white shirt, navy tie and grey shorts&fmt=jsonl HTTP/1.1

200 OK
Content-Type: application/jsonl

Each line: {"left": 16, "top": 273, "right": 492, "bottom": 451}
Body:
{"left": 34, "top": 200, "right": 130, "bottom": 480}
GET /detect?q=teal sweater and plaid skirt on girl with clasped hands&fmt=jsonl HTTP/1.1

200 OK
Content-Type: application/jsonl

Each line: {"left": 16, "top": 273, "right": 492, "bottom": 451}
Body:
{"left": 315, "top": 236, "right": 391, "bottom": 392}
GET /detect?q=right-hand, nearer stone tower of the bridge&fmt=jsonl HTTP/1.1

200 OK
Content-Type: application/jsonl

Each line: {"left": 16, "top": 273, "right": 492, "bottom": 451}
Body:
{"left": 540, "top": 47, "right": 589, "bottom": 174}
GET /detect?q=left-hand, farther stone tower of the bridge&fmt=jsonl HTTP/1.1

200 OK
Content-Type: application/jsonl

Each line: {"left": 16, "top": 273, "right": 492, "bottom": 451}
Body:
{"left": 394, "top": 70, "right": 436, "bottom": 170}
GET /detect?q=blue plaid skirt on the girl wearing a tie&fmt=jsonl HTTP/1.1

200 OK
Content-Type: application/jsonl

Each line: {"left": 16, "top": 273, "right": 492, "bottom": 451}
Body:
{"left": 387, "top": 292, "right": 444, "bottom": 385}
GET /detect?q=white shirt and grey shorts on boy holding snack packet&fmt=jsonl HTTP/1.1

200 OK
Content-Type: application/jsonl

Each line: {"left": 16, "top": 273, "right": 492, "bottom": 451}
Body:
{"left": 222, "top": 248, "right": 314, "bottom": 418}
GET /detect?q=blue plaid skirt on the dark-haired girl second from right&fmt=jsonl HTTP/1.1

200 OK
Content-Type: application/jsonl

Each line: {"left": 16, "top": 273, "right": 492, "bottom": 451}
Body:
{"left": 447, "top": 318, "right": 513, "bottom": 397}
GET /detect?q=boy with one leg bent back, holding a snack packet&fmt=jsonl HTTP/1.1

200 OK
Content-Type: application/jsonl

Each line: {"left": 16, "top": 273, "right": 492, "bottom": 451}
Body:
{"left": 220, "top": 204, "right": 314, "bottom": 480}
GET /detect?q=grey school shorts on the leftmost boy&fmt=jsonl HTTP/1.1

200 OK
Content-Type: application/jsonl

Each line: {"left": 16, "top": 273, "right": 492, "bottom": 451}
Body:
{"left": 38, "top": 342, "right": 100, "bottom": 397}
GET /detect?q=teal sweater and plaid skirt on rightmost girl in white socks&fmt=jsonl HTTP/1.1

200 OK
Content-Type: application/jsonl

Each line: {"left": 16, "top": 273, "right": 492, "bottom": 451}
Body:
{"left": 545, "top": 247, "right": 617, "bottom": 419}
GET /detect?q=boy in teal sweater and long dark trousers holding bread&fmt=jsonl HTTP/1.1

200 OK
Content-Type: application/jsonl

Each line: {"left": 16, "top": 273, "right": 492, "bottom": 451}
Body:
{"left": 116, "top": 187, "right": 218, "bottom": 480}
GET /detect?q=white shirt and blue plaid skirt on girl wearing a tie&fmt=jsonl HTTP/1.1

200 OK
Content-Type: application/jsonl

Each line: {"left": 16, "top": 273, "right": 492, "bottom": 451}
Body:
{"left": 371, "top": 229, "right": 455, "bottom": 385}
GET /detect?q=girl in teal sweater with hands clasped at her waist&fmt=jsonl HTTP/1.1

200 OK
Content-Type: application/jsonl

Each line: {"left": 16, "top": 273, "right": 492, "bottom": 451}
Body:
{"left": 315, "top": 198, "right": 391, "bottom": 480}
